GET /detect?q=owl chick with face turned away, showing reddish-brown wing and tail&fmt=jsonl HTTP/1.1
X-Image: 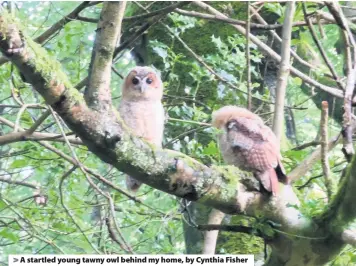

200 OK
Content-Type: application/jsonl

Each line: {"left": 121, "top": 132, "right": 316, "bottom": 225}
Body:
{"left": 212, "top": 106, "right": 287, "bottom": 195}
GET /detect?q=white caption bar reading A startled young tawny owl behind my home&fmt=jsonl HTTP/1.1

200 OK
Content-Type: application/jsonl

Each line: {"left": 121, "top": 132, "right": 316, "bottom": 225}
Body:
{"left": 9, "top": 255, "right": 254, "bottom": 266}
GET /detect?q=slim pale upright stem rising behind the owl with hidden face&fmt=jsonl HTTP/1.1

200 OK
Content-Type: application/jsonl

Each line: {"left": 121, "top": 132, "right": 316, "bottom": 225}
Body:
{"left": 273, "top": 1, "right": 295, "bottom": 141}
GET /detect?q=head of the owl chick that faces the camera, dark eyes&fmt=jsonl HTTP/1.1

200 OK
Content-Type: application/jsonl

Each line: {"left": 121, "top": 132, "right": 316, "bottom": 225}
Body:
{"left": 122, "top": 66, "right": 163, "bottom": 101}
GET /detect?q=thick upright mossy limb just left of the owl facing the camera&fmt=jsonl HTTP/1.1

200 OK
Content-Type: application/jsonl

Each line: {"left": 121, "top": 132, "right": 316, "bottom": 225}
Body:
{"left": 85, "top": 1, "right": 126, "bottom": 112}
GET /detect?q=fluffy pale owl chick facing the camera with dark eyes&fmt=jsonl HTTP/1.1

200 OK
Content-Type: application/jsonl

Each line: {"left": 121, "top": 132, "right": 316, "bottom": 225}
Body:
{"left": 119, "top": 67, "right": 165, "bottom": 191}
